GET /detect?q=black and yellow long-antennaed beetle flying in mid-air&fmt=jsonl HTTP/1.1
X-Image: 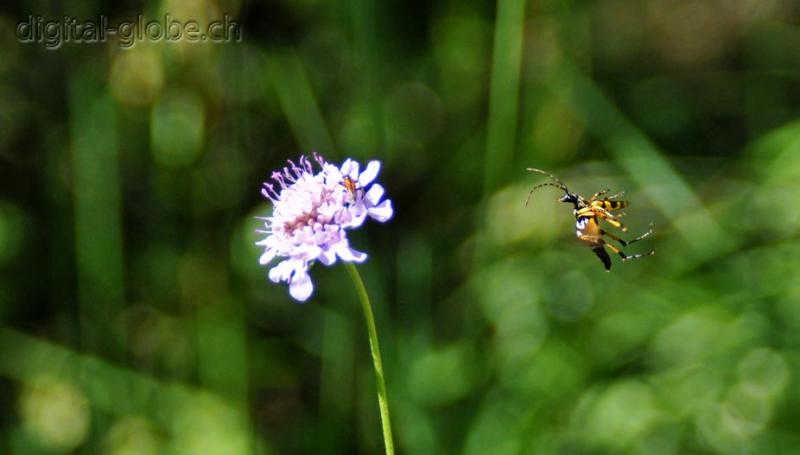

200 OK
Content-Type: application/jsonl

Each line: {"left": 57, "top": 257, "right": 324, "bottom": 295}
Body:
{"left": 525, "top": 167, "right": 655, "bottom": 270}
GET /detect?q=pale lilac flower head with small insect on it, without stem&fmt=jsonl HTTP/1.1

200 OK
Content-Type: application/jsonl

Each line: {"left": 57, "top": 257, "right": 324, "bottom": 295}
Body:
{"left": 256, "top": 154, "right": 393, "bottom": 302}
